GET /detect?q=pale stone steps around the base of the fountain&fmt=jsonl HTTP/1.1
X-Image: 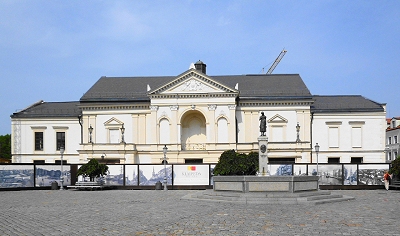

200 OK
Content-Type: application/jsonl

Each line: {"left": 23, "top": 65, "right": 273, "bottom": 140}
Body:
{"left": 182, "top": 190, "right": 355, "bottom": 205}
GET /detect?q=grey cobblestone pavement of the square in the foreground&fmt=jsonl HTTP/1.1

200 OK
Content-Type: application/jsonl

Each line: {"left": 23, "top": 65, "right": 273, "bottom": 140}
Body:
{"left": 0, "top": 190, "right": 400, "bottom": 236}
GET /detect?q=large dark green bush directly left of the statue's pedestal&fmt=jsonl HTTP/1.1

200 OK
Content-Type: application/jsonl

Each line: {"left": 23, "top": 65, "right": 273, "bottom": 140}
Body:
{"left": 214, "top": 150, "right": 258, "bottom": 175}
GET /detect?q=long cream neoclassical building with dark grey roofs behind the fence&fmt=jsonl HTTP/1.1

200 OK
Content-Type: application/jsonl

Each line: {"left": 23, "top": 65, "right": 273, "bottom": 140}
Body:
{"left": 11, "top": 61, "right": 386, "bottom": 163}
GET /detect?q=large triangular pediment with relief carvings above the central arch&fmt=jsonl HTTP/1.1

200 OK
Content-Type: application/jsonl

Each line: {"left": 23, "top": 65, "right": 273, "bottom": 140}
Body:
{"left": 149, "top": 69, "right": 238, "bottom": 95}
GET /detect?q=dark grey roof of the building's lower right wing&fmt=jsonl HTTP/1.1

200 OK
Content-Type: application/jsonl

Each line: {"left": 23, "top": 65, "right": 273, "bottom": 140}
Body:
{"left": 311, "top": 95, "right": 384, "bottom": 113}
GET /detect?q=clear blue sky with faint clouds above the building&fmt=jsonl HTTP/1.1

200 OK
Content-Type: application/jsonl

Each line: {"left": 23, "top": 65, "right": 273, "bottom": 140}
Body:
{"left": 0, "top": 0, "right": 400, "bottom": 135}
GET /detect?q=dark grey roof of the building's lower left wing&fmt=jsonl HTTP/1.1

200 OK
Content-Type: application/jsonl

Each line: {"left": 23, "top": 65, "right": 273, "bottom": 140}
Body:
{"left": 11, "top": 101, "right": 82, "bottom": 118}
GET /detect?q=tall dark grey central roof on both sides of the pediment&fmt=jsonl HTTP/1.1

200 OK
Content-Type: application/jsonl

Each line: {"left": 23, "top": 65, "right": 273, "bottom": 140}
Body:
{"left": 80, "top": 74, "right": 311, "bottom": 102}
